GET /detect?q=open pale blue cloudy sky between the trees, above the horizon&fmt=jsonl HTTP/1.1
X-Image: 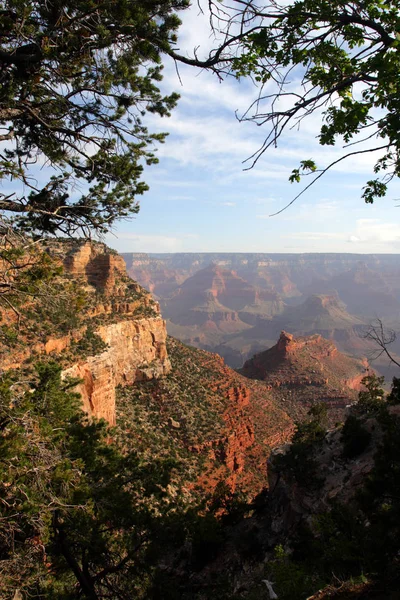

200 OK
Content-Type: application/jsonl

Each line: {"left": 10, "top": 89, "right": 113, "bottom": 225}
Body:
{"left": 106, "top": 7, "right": 400, "bottom": 253}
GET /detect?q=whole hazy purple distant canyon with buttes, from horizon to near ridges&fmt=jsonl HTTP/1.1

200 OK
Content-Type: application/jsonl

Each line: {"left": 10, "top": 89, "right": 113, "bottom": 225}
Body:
{"left": 122, "top": 253, "right": 400, "bottom": 381}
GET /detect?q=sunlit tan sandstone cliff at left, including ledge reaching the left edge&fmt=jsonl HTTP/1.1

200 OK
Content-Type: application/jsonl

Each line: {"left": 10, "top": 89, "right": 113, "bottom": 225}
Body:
{"left": 0, "top": 240, "right": 170, "bottom": 425}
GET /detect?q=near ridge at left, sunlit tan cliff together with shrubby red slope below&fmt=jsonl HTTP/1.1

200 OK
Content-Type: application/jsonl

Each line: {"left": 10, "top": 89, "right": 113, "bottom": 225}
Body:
{"left": 0, "top": 241, "right": 293, "bottom": 497}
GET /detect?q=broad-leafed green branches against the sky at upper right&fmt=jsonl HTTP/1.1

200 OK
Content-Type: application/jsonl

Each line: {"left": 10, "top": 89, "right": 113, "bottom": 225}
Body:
{"left": 174, "top": 0, "right": 400, "bottom": 203}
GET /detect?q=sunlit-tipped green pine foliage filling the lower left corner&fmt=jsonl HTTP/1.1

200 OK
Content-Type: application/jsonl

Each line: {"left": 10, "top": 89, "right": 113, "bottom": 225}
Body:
{"left": 0, "top": 362, "right": 184, "bottom": 600}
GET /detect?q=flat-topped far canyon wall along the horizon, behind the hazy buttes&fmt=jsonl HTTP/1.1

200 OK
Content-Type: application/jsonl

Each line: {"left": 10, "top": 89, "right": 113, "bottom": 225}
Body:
{"left": 123, "top": 253, "right": 400, "bottom": 308}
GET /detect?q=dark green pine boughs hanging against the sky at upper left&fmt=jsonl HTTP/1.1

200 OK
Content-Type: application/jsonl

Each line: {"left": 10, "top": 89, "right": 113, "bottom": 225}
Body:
{"left": 0, "top": 0, "right": 188, "bottom": 235}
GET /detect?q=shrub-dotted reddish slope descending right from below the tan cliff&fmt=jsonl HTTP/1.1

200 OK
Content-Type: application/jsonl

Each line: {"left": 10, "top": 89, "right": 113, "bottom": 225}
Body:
{"left": 128, "top": 338, "right": 293, "bottom": 498}
